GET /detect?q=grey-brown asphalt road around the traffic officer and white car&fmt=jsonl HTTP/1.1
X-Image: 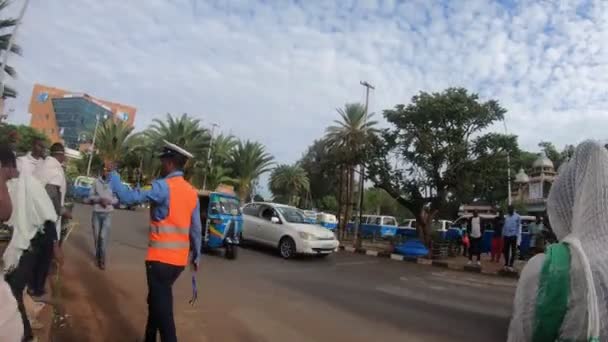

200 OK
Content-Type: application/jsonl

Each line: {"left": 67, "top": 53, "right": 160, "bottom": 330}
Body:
{"left": 55, "top": 207, "right": 515, "bottom": 342}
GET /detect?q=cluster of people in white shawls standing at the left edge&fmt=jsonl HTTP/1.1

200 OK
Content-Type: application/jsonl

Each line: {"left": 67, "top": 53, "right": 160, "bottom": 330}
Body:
{"left": 0, "top": 138, "right": 71, "bottom": 342}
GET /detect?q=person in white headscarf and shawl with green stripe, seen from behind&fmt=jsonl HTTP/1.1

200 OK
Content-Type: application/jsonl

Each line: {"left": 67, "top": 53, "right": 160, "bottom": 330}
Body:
{"left": 508, "top": 141, "right": 608, "bottom": 342}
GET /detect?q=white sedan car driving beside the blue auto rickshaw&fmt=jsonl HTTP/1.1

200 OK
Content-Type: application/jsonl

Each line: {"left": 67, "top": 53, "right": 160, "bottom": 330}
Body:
{"left": 241, "top": 203, "right": 340, "bottom": 259}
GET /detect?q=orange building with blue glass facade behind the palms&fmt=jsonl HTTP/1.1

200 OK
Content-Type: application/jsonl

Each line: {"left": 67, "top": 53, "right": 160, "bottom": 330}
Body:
{"left": 29, "top": 84, "right": 136, "bottom": 148}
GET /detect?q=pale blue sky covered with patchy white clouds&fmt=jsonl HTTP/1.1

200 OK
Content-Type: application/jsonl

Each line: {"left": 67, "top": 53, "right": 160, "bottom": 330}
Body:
{"left": 7, "top": 0, "right": 608, "bottom": 166}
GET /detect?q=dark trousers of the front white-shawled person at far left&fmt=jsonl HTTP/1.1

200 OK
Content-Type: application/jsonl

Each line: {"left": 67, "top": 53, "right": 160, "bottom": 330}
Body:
{"left": 4, "top": 250, "right": 36, "bottom": 341}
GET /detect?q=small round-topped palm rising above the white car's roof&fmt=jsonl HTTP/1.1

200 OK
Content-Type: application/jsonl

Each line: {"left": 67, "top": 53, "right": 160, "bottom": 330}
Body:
{"left": 269, "top": 164, "right": 310, "bottom": 205}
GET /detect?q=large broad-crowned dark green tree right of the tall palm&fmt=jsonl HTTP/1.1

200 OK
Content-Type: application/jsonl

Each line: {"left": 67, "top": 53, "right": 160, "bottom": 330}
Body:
{"left": 369, "top": 88, "right": 513, "bottom": 245}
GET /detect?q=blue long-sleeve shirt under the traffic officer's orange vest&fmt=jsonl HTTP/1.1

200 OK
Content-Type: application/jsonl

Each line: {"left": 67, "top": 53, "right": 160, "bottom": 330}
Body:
{"left": 110, "top": 171, "right": 202, "bottom": 262}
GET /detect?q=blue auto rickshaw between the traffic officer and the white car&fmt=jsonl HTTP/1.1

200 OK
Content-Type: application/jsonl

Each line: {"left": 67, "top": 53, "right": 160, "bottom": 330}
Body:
{"left": 198, "top": 191, "right": 243, "bottom": 259}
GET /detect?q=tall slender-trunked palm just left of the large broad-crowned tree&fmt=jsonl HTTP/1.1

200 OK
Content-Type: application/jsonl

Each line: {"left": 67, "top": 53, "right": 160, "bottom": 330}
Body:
{"left": 325, "top": 103, "right": 378, "bottom": 239}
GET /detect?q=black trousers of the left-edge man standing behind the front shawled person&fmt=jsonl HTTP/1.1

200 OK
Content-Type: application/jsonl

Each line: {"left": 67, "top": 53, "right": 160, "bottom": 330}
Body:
{"left": 28, "top": 222, "right": 57, "bottom": 297}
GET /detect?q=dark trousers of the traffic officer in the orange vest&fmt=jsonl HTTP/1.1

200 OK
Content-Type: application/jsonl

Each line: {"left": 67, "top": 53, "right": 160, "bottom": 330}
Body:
{"left": 145, "top": 261, "right": 184, "bottom": 342}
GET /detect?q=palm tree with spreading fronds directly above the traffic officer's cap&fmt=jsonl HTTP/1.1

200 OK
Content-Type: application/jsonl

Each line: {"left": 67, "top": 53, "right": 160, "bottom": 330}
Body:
{"left": 144, "top": 114, "right": 210, "bottom": 178}
